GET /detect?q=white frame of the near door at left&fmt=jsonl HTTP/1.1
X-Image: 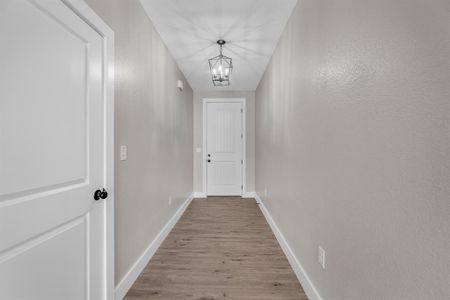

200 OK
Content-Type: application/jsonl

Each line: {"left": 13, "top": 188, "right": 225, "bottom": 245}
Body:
{"left": 61, "top": 0, "right": 115, "bottom": 300}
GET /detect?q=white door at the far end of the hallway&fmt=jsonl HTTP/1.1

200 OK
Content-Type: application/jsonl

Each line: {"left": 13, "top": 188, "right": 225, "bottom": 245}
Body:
{"left": 206, "top": 102, "right": 243, "bottom": 196}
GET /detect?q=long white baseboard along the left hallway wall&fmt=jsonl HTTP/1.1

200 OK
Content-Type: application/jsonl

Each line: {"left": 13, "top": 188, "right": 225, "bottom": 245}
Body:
{"left": 115, "top": 194, "right": 194, "bottom": 300}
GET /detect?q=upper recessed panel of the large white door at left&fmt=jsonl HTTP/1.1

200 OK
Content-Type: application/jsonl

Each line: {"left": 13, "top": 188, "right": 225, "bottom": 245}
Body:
{"left": 0, "top": 1, "right": 88, "bottom": 197}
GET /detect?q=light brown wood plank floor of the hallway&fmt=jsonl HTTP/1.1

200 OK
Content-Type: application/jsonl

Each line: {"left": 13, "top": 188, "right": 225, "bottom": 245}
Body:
{"left": 125, "top": 197, "right": 308, "bottom": 300}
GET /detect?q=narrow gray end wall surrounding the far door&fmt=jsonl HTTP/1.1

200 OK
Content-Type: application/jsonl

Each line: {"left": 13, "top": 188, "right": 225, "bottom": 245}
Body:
{"left": 194, "top": 91, "right": 255, "bottom": 192}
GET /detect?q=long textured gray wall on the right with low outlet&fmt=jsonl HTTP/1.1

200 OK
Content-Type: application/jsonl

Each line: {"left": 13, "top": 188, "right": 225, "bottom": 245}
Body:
{"left": 256, "top": 0, "right": 450, "bottom": 300}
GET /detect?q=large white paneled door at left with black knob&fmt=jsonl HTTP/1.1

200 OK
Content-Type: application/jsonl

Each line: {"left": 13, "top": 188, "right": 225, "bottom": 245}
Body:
{"left": 0, "top": 0, "right": 108, "bottom": 300}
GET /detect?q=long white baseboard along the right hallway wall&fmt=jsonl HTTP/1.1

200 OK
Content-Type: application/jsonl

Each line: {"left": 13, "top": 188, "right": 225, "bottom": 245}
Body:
{"left": 255, "top": 194, "right": 322, "bottom": 300}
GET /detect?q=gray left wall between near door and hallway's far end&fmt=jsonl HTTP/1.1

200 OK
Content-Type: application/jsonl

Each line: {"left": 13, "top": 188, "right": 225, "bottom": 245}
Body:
{"left": 87, "top": 0, "right": 193, "bottom": 283}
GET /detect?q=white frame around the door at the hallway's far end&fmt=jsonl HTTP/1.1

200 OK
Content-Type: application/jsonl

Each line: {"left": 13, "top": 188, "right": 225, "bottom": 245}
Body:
{"left": 202, "top": 98, "right": 247, "bottom": 198}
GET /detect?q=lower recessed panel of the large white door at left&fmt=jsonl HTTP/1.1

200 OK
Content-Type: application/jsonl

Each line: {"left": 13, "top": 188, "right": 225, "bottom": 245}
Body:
{"left": 0, "top": 218, "right": 88, "bottom": 300}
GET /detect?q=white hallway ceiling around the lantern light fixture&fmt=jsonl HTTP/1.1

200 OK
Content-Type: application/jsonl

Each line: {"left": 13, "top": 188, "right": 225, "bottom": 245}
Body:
{"left": 141, "top": 0, "right": 297, "bottom": 91}
